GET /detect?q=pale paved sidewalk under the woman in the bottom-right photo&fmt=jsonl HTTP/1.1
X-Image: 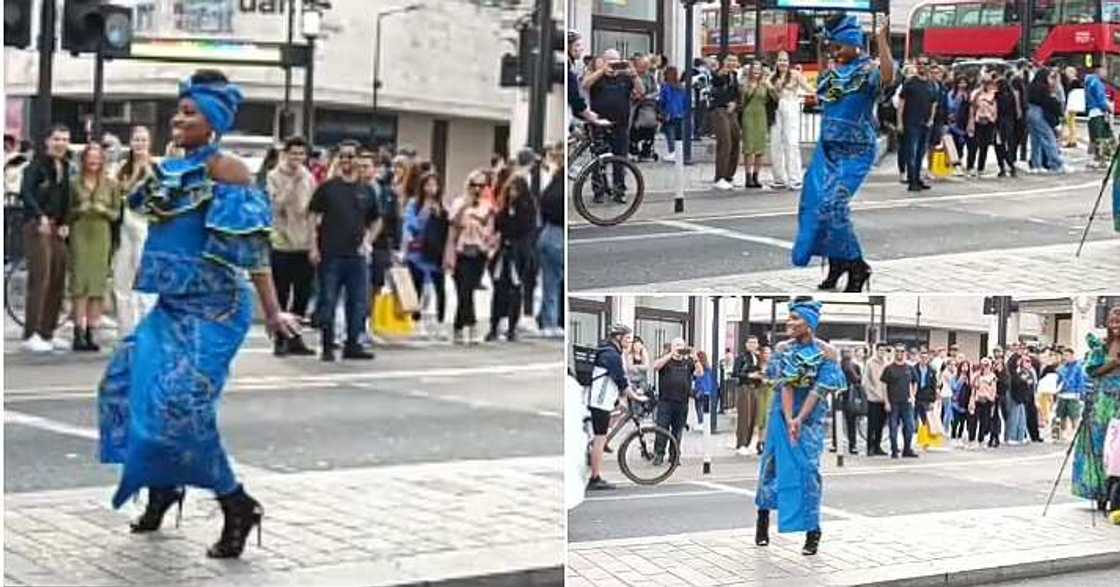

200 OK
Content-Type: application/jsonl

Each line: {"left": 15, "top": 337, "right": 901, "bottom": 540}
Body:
{"left": 566, "top": 504, "right": 1120, "bottom": 587}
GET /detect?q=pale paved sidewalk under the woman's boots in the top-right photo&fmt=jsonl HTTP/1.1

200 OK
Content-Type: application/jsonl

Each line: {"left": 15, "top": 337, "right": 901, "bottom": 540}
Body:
{"left": 595, "top": 238, "right": 1120, "bottom": 294}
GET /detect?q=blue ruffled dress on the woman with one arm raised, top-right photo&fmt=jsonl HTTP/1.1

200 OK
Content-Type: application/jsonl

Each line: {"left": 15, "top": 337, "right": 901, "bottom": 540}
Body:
{"left": 792, "top": 57, "right": 881, "bottom": 267}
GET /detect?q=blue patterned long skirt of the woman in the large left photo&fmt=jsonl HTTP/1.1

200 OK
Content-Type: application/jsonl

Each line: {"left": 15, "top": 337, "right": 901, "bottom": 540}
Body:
{"left": 97, "top": 283, "right": 253, "bottom": 507}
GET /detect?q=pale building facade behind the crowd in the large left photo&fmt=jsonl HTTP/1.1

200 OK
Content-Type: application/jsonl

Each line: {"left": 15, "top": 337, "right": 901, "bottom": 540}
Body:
{"left": 4, "top": 0, "right": 563, "bottom": 192}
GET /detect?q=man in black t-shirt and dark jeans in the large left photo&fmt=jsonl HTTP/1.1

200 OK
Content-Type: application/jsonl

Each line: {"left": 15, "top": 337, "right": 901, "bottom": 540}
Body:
{"left": 309, "top": 140, "right": 379, "bottom": 362}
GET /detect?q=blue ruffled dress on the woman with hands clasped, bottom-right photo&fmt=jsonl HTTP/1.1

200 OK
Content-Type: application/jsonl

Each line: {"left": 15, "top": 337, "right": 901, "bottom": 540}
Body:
{"left": 755, "top": 341, "right": 848, "bottom": 532}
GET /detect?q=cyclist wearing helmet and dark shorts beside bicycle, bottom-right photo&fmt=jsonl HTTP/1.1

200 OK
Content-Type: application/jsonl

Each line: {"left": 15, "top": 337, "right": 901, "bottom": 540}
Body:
{"left": 587, "top": 324, "right": 646, "bottom": 491}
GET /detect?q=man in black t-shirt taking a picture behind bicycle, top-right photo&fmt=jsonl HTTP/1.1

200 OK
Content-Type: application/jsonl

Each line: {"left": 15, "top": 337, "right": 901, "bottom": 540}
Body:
{"left": 584, "top": 49, "right": 645, "bottom": 194}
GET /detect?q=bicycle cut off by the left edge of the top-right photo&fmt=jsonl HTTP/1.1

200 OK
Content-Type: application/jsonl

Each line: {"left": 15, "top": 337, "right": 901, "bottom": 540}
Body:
{"left": 568, "top": 122, "right": 645, "bottom": 226}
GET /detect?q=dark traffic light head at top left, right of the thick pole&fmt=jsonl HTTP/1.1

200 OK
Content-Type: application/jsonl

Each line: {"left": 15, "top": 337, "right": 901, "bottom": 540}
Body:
{"left": 63, "top": 0, "right": 132, "bottom": 57}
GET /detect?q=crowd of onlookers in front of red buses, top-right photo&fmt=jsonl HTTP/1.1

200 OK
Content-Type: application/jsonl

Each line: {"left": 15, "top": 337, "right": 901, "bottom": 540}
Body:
{"left": 569, "top": 32, "right": 1114, "bottom": 192}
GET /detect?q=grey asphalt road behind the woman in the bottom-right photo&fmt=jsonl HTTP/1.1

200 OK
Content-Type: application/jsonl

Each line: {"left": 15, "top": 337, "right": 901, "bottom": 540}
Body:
{"left": 568, "top": 439, "right": 1076, "bottom": 542}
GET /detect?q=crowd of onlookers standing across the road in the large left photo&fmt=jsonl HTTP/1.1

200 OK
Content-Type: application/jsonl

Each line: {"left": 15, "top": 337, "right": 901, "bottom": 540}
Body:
{"left": 4, "top": 125, "right": 563, "bottom": 361}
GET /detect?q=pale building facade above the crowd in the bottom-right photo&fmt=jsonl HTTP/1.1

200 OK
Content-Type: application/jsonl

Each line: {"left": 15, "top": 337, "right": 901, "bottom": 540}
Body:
{"left": 569, "top": 294, "right": 1120, "bottom": 367}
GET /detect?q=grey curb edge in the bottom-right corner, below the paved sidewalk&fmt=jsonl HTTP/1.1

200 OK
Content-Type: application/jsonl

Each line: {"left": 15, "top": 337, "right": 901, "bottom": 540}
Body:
{"left": 859, "top": 551, "right": 1120, "bottom": 587}
